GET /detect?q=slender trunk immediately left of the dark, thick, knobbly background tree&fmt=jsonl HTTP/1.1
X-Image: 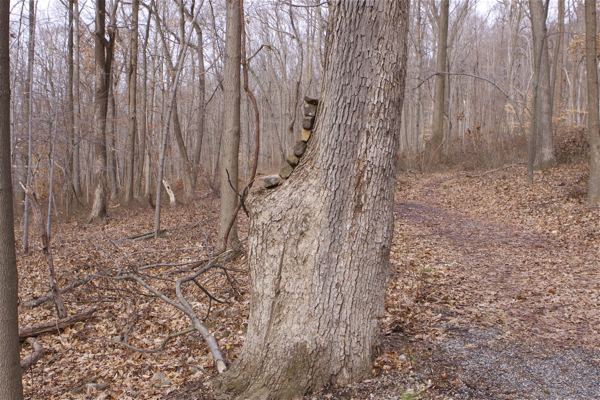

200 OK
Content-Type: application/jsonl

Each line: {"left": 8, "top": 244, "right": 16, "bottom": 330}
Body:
{"left": 73, "top": 0, "right": 82, "bottom": 197}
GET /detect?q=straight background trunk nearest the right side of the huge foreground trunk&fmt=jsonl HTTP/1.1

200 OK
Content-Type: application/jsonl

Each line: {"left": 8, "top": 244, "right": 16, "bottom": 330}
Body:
{"left": 429, "top": 0, "right": 450, "bottom": 166}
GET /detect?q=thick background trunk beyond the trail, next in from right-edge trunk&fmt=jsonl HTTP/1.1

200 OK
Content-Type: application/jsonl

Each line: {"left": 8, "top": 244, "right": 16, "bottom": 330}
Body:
{"left": 529, "top": 0, "right": 556, "bottom": 170}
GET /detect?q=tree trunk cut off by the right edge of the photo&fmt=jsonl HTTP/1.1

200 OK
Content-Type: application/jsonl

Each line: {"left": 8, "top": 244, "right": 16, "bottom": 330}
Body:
{"left": 585, "top": 0, "right": 600, "bottom": 206}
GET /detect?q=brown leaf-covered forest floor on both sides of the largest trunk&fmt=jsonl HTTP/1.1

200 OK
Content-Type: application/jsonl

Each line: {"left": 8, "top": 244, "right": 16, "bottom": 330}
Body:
{"left": 18, "top": 164, "right": 600, "bottom": 400}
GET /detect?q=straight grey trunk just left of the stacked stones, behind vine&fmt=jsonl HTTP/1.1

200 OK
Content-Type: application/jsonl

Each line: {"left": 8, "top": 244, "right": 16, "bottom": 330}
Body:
{"left": 218, "top": 0, "right": 242, "bottom": 246}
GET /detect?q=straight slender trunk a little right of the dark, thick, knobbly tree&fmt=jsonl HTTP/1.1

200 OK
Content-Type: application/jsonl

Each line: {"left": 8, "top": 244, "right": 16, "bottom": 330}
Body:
{"left": 125, "top": 0, "right": 140, "bottom": 203}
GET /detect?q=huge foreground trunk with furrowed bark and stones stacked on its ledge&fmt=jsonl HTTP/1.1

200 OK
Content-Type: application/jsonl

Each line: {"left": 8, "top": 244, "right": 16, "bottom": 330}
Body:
{"left": 216, "top": 0, "right": 409, "bottom": 399}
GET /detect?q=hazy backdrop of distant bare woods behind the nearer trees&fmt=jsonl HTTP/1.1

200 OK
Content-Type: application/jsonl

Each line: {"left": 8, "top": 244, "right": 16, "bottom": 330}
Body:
{"left": 4, "top": 0, "right": 597, "bottom": 217}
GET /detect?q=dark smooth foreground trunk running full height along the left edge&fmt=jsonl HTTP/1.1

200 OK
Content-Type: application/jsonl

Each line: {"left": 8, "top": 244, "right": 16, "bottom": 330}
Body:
{"left": 0, "top": 1, "right": 23, "bottom": 400}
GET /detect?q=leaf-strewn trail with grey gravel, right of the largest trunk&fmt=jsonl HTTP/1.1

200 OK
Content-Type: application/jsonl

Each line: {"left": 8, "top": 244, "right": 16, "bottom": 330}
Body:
{"left": 395, "top": 177, "right": 600, "bottom": 399}
